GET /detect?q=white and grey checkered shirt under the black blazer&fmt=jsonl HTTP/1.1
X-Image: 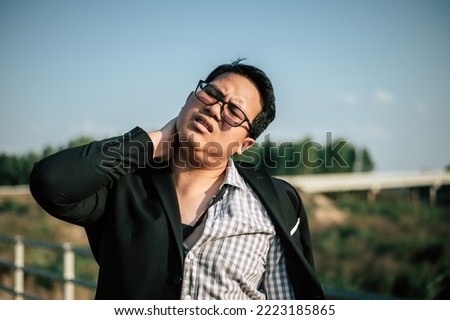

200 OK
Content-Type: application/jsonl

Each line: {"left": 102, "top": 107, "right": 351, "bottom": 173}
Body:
{"left": 181, "top": 161, "right": 294, "bottom": 300}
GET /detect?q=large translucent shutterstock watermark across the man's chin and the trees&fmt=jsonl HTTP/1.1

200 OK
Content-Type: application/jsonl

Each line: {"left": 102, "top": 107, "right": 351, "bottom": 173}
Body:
{"left": 101, "top": 132, "right": 349, "bottom": 169}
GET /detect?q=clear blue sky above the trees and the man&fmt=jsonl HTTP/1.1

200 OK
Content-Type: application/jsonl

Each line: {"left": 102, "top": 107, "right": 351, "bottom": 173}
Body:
{"left": 0, "top": 0, "right": 450, "bottom": 171}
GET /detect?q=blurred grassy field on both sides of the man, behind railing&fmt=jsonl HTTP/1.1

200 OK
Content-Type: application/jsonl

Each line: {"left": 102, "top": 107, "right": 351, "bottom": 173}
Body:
{"left": 0, "top": 189, "right": 450, "bottom": 299}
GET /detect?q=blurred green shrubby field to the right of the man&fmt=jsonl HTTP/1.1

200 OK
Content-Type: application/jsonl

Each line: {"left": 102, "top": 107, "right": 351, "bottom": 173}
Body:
{"left": 310, "top": 190, "right": 450, "bottom": 299}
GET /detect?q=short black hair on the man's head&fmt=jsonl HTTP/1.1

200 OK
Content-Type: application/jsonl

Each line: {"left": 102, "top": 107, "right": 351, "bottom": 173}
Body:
{"left": 205, "top": 59, "right": 275, "bottom": 139}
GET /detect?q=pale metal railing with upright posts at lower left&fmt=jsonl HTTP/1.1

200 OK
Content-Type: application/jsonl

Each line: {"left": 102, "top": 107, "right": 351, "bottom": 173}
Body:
{"left": 0, "top": 236, "right": 96, "bottom": 300}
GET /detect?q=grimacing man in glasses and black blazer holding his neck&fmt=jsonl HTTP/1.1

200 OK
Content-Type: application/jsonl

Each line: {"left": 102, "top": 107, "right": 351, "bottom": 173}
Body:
{"left": 30, "top": 61, "right": 324, "bottom": 299}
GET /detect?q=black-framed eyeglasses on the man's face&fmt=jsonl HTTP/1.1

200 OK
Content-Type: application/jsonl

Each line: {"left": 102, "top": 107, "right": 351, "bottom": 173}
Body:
{"left": 195, "top": 80, "right": 254, "bottom": 137}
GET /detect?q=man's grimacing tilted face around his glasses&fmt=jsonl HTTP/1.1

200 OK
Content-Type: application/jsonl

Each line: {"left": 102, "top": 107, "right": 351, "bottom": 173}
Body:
{"left": 177, "top": 73, "right": 261, "bottom": 162}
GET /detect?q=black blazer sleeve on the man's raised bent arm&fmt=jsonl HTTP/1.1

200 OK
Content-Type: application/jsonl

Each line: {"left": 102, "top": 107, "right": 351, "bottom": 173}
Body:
{"left": 30, "top": 127, "right": 153, "bottom": 226}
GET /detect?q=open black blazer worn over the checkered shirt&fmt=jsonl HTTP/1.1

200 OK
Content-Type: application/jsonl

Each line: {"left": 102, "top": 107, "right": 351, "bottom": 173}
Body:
{"left": 30, "top": 128, "right": 324, "bottom": 299}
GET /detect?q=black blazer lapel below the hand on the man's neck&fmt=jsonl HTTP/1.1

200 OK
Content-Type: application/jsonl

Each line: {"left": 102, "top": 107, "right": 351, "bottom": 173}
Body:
{"left": 149, "top": 168, "right": 183, "bottom": 261}
